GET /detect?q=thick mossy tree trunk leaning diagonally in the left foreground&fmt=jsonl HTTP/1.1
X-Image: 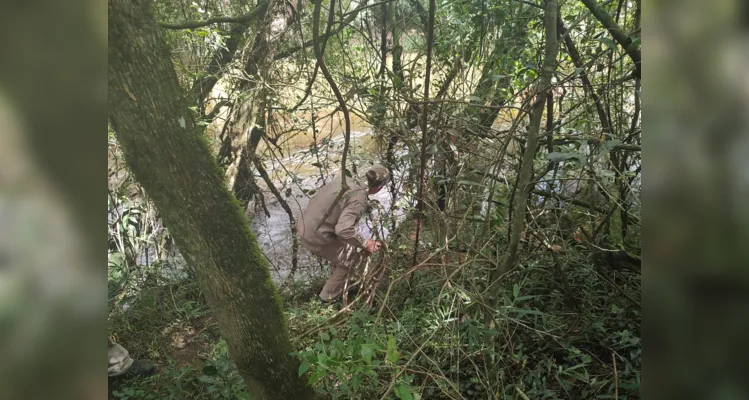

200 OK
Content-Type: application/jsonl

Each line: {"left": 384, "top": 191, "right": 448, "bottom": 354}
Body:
{"left": 109, "top": 0, "right": 313, "bottom": 400}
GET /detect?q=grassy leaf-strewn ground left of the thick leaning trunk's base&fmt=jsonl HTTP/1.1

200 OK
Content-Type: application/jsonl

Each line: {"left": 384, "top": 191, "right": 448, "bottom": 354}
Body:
{"left": 109, "top": 268, "right": 225, "bottom": 399}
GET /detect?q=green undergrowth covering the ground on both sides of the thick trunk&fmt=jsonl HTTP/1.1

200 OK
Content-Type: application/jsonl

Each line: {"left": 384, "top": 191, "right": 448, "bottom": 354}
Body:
{"left": 109, "top": 231, "right": 641, "bottom": 399}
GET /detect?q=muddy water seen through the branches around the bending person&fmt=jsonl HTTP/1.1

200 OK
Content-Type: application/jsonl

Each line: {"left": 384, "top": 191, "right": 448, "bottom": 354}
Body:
{"left": 108, "top": 130, "right": 412, "bottom": 290}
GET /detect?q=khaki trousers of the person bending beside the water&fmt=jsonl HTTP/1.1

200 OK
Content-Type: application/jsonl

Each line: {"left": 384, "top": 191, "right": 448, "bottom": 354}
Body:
{"left": 302, "top": 239, "right": 362, "bottom": 301}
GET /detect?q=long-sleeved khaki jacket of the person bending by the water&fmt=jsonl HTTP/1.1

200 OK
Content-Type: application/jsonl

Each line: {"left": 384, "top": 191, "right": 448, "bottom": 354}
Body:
{"left": 298, "top": 174, "right": 368, "bottom": 251}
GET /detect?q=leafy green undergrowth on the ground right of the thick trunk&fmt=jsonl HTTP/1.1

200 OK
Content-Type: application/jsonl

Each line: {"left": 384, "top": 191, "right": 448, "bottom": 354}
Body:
{"left": 292, "top": 245, "right": 641, "bottom": 399}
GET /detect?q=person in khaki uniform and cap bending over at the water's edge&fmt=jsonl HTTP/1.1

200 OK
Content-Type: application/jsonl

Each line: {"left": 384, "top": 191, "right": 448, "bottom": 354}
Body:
{"left": 298, "top": 164, "right": 390, "bottom": 303}
